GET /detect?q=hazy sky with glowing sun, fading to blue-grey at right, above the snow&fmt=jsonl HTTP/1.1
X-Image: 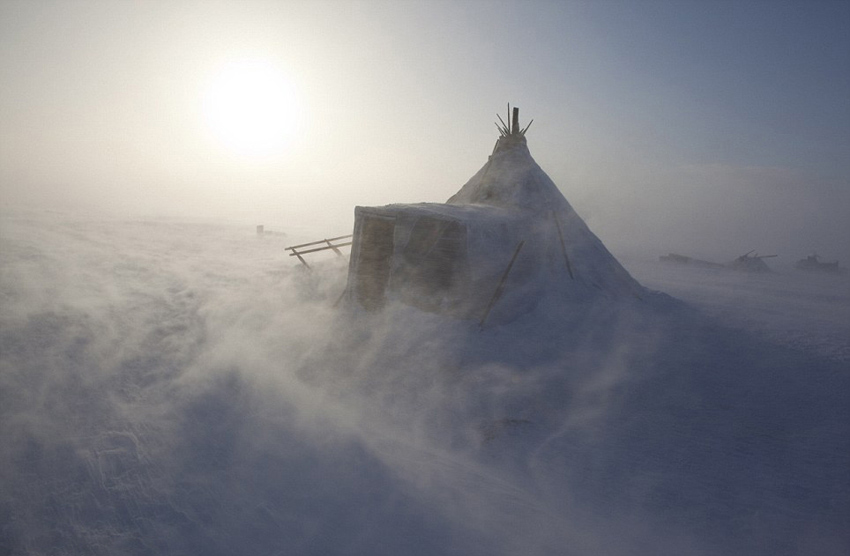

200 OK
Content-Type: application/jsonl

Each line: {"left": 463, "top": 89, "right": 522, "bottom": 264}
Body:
{"left": 0, "top": 0, "right": 850, "bottom": 264}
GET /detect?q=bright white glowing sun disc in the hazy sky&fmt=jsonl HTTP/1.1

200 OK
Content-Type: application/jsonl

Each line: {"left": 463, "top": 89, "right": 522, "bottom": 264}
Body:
{"left": 204, "top": 59, "right": 302, "bottom": 157}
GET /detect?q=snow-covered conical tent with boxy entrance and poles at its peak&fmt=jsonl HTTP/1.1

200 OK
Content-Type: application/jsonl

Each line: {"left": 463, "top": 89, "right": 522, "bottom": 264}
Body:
{"left": 347, "top": 108, "right": 644, "bottom": 321}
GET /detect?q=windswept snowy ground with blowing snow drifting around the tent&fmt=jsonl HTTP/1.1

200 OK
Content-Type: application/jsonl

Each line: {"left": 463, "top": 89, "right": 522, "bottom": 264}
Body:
{"left": 0, "top": 214, "right": 850, "bottom": 555}
